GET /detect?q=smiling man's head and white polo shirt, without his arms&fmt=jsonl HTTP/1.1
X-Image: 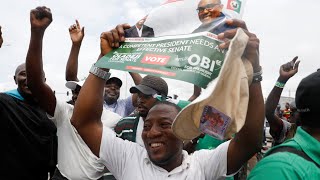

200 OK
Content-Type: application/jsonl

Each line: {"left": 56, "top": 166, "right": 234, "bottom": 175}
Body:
{"left": 100, "top": 101, "right": 230, "bottom": 180}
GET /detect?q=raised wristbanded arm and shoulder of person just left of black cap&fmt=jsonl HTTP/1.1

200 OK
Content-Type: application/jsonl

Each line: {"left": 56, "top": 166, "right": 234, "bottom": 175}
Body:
{"left": 265, "top": 57, "right": 300, "bottom": 145}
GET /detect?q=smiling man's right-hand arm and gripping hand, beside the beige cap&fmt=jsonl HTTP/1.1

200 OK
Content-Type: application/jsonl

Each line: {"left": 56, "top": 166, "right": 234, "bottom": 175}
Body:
{"left": 219, "top": 20, "right": 264, "bottom": 174}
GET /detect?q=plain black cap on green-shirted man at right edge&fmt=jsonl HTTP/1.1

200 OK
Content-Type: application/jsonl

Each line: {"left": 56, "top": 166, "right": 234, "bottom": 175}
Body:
{"left": 295, "top": 70, "right": 320, "bottom": 125}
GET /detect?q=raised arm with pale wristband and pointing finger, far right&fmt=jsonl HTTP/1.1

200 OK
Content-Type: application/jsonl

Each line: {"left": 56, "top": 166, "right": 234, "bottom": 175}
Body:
{"left": 265, "top": 56, "right": 300, "bottom": 139}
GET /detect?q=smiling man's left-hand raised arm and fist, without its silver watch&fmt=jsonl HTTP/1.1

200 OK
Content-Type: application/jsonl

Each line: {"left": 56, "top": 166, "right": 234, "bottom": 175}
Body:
{"left": 71, "top": 25, "right": 130, "bottom": 156}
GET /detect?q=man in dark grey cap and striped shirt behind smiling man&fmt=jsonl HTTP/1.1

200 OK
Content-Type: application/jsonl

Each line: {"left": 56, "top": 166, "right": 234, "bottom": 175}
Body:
{"left": 114, "top": 75, "right": 168, "bottom": 146}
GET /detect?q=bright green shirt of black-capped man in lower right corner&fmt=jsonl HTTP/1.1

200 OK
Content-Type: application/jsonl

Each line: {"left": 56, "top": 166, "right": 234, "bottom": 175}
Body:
{"left": 249, "top": 127, "right": 320, "bottom": 180}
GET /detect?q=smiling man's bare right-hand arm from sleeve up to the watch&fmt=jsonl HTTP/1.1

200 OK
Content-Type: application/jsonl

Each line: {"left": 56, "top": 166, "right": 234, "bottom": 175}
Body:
{"left": 228, "top": 83, "right": 264, "bottom": 174}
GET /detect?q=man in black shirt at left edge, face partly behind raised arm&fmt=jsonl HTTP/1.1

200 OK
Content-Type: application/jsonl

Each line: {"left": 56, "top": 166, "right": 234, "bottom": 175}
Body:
{"left": 0, "top": 64, "right": 57, "bottom": 180}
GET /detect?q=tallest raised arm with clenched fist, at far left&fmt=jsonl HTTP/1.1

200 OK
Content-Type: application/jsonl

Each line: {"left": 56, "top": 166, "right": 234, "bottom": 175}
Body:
{"left": 26, "top": 6, "right": 56, "bottom": 116}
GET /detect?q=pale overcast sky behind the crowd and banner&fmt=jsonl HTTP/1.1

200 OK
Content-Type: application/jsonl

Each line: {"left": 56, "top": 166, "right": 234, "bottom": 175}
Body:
{"left": 0, "top": 0, "right": 320, "bottom": 99}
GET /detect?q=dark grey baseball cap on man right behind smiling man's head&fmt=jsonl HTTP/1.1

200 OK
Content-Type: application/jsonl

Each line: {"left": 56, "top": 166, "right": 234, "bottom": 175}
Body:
{"left": 130, "top": 75, "right": 168, "bottom": 96}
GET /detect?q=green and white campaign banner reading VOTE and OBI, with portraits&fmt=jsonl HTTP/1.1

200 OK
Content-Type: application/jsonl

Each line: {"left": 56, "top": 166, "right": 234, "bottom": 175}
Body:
{"left": 96, "top": 0, "right": 244, "bottom": 88}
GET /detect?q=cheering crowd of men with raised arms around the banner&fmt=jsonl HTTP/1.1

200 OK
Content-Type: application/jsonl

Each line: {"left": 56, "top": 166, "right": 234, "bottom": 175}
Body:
{"left": 0, "top": 0, "right": 320, "bottom": 180}
